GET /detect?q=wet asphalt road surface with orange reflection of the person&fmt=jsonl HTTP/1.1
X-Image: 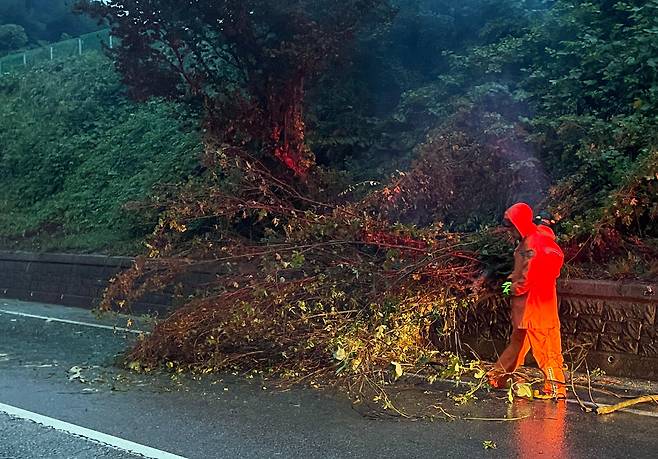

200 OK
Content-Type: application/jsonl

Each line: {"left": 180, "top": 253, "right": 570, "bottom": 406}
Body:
{"left": 0, "top": 300, "right": 658, "bottom": 458}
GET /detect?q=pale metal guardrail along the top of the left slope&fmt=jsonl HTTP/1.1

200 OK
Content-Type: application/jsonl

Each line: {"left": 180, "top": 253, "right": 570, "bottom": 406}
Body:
{"left": 0, "top": 29, "right": 116, "bottom": 74}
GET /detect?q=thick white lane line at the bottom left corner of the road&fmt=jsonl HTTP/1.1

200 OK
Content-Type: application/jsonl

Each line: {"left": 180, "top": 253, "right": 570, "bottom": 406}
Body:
{"left": 0, "top": 403, "right": 185, "bottom": 459}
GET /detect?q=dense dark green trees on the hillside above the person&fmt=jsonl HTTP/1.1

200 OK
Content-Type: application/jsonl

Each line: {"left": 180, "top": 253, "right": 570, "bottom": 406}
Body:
{"left": 313, "top": 0, "right": 658, "bottom": 246}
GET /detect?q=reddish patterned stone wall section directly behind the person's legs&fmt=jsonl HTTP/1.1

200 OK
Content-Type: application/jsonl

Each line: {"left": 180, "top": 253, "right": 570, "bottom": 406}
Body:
{"left": 459, "top": 280, "right": 658, "bottom": 380}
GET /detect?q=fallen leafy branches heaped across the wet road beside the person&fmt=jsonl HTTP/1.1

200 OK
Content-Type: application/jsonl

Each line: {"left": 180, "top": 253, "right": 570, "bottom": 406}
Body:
{"left": 102, "top": 145, "right": 492, "bottom": 394}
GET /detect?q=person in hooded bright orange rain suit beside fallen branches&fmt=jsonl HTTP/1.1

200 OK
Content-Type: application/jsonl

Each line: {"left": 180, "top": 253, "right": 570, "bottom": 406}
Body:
{"left": 488, "top": 203, "right": 566, "bottom": 399}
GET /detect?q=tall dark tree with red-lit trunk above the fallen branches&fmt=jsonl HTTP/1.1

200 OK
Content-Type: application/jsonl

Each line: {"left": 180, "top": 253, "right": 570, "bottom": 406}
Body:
{"left": 79, "top": 0, "right": 392, "bottom": 176}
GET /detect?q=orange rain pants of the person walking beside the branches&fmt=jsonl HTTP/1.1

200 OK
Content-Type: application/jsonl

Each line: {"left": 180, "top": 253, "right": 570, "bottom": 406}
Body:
{"left": 489, "top": 327, "right": 567, "bottom": 398}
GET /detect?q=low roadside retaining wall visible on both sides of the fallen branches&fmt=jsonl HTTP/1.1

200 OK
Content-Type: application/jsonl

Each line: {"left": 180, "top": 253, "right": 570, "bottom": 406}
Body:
{"left": 0, "top": 251, "right": 658, "bottom": 380}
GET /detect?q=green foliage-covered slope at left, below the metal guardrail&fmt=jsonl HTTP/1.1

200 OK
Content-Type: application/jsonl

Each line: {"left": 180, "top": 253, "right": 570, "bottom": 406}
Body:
{"left": 0, "top": 53, "right": 201, "bottom": 253}
